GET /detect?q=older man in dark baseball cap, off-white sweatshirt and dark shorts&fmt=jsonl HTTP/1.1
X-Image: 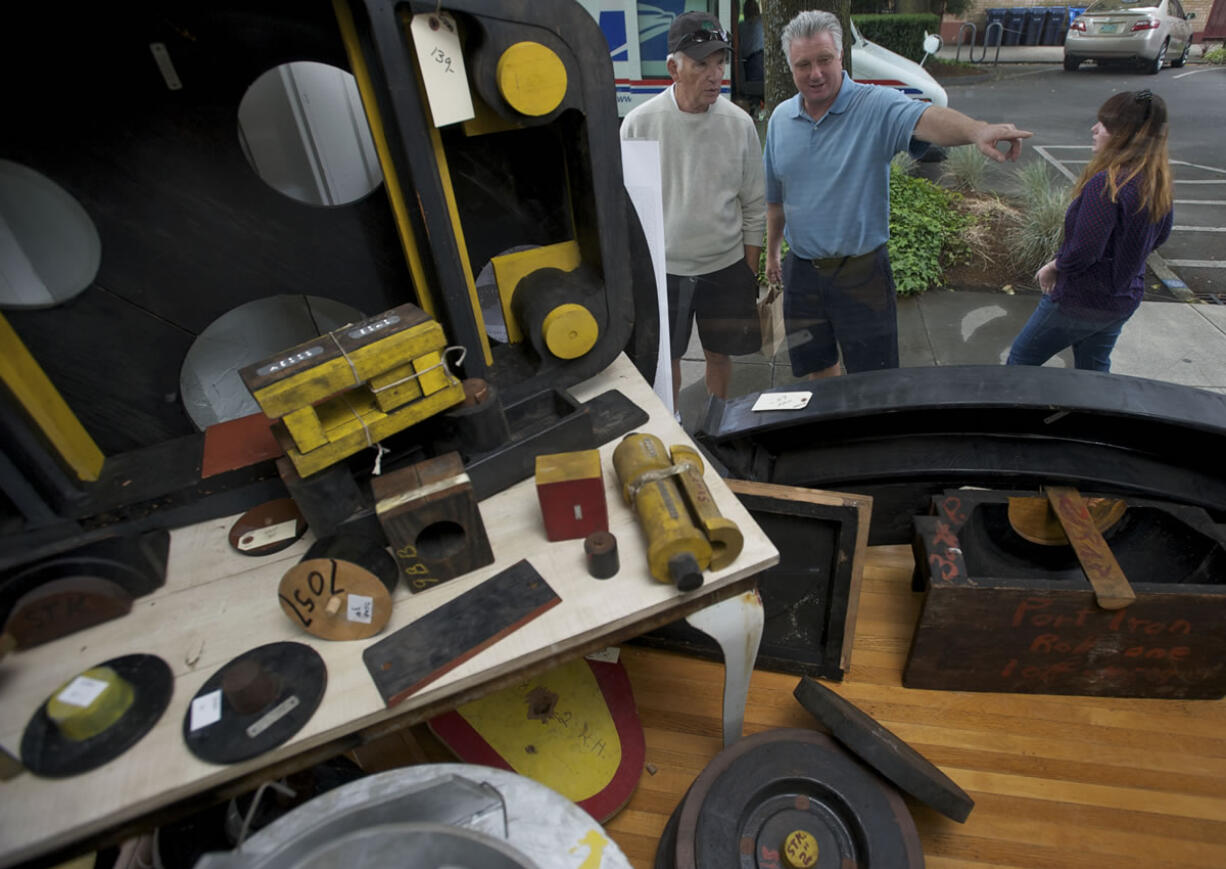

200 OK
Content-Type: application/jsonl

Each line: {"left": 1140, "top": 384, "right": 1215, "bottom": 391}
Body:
{"left": 622, "top": 12, "right": 766, "bottom": 407}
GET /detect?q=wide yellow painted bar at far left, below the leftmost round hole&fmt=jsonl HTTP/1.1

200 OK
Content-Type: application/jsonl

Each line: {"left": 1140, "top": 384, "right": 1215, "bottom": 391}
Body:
{"left": 0, "top": 314, "right": 105, "bottom": 480}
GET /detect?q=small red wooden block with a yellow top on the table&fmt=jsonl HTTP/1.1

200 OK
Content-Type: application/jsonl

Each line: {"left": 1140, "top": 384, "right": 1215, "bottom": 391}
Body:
{"left": 536, "top": 450, "right": 609, "bottom": 541}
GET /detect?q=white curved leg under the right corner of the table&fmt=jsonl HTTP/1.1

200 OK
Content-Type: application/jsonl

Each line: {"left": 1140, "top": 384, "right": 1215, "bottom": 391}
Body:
{"left": 685, "top": 588, "right": 763, "bottom": 748}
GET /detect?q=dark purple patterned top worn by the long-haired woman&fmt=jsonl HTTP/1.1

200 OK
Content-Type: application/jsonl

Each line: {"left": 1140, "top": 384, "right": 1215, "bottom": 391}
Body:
{"left": 1052, "top": 172, "right": 1175, "bottom": 319}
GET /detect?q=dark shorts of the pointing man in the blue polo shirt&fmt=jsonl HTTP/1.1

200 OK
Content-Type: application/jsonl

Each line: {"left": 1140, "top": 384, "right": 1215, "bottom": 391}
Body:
{"left": 783, "top": 244, "right": 899, "bottom": 378}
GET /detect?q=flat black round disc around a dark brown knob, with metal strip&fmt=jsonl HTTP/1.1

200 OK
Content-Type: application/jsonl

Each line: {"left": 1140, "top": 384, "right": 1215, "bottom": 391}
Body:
{"left": 183, "top": 642, "right": 327, "bottom": 764}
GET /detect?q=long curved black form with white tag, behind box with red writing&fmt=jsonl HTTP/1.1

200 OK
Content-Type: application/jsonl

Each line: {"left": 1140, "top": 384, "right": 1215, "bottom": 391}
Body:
{"left": 695, "top": 365, "right": 1226, "bottom": 545}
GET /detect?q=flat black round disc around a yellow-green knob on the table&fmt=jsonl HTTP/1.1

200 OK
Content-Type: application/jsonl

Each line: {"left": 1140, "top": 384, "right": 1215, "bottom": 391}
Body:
{"left": 21, "top": 655, "right": 174, "bottom": 778}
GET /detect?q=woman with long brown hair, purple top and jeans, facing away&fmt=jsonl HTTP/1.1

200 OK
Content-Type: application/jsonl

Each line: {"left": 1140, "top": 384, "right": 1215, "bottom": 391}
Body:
{"left": 1008, "top": 91, "right": 1175, "bottom": 371}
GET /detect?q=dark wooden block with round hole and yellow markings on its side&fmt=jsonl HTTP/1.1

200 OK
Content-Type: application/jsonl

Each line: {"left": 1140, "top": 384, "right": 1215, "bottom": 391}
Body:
{"left": 370, "top": 452, "right": 494, "bottom": 593}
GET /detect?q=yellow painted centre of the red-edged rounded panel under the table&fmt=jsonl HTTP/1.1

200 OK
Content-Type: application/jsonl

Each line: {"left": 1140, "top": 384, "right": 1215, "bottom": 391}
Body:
{"left": 456, "top": 658, "right": 622, "bottom": 803}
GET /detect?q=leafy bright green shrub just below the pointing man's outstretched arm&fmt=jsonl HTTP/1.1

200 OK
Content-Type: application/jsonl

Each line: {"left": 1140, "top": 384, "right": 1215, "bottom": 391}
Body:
{"left": 889, "top": 172, "right": 972, "bottom": 295}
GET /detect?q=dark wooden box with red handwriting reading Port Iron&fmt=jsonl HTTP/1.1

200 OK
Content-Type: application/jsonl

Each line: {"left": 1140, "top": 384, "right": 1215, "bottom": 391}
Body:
{"left": 902, "top": 490, "right": 1226, "bottom": 700}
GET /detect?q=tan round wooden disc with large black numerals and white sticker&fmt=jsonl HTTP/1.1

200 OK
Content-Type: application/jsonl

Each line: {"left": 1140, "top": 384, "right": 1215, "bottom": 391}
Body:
{"left": 277, "top": 558, "right": 391, "bottom": 640}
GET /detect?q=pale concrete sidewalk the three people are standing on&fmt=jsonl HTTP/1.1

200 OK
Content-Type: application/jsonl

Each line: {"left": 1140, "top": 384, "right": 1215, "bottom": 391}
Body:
{"left": 680, "top": 289, "right": 1226, "bottom": 430}
